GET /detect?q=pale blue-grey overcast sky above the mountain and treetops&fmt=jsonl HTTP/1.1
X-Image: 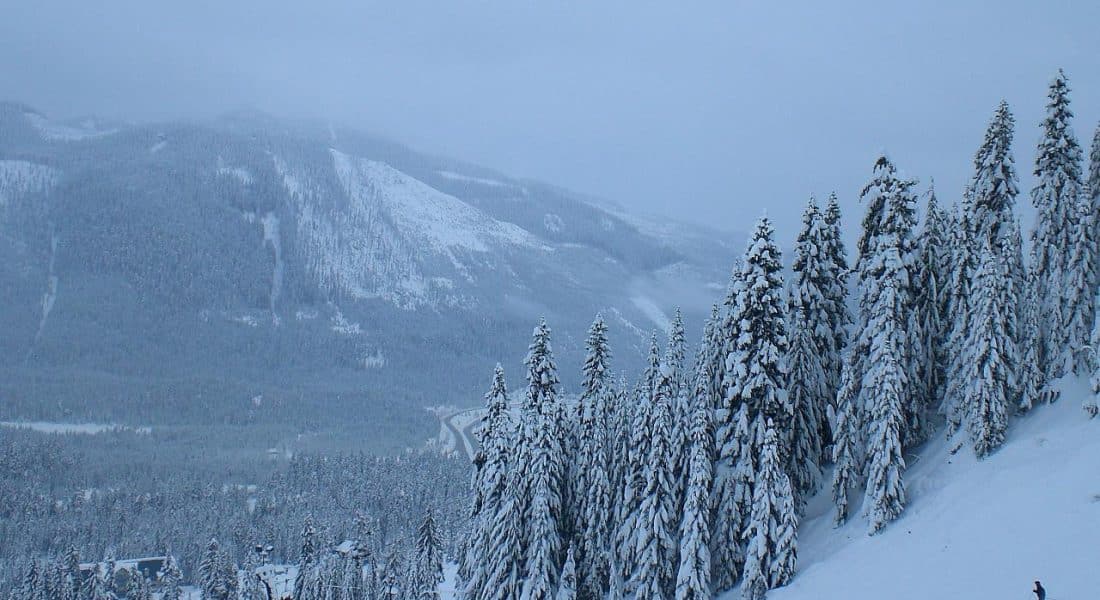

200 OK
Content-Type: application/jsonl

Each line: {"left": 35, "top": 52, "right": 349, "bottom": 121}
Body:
{"left": 0, "top": 0, "right": 1100, "bottom": 241}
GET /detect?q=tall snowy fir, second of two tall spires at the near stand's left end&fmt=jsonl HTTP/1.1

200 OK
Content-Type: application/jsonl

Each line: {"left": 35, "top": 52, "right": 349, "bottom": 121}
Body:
{"left": 572, "top": 316, "right": 615, "bottom": 599}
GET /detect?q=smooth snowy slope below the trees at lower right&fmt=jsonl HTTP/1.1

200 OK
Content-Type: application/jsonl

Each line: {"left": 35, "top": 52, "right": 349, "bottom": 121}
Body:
{"left": 768, "top": 382, "right": 1100, "bottom": 600}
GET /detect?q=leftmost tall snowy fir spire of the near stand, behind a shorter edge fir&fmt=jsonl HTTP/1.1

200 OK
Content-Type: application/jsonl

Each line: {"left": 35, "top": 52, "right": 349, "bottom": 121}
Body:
{"left": 521, "top": 320, "right": 565, "bottom": 600}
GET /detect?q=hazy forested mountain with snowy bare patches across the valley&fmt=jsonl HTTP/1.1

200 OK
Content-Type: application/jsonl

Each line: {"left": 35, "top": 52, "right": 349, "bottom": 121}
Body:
{"left": 0, "top": 103, "right": 743, "bottom": 449}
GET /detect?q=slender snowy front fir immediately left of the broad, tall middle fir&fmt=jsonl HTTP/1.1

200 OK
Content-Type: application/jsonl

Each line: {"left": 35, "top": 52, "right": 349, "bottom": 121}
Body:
{"left": 675, "top": 378, "right": 714, "bottom": 600}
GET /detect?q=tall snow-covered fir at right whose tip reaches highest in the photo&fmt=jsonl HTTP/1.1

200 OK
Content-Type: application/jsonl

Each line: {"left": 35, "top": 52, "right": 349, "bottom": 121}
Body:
{"left": 1032, "top": 69, "right": 1081, "bottom": 381}
